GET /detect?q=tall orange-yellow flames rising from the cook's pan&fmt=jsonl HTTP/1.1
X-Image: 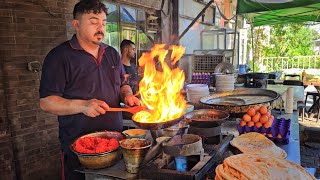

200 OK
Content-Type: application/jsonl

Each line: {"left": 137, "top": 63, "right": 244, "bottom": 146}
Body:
{"left": 133, "top": 44, "right": 186, "bottom": 123}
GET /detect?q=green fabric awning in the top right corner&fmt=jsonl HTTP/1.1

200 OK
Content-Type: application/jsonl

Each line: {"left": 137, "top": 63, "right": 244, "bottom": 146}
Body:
{"left": 237, "top": 0, "right": 320, "bottom": 26}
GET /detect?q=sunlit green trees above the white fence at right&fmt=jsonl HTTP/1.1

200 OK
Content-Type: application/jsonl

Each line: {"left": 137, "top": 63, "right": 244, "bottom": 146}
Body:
{"left": 248, "top": 23, "right": 320, "bottom": 71}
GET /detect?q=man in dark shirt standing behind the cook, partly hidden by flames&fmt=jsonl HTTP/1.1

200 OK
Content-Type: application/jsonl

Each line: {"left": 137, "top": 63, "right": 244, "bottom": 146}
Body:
{"left": 120, "top": 39, "right": 139, "bottom": 94}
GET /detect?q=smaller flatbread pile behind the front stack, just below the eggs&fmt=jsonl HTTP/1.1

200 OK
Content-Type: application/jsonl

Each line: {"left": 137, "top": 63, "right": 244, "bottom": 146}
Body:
{"left": 230, "top": 132, "right": 287, "bottom": 159}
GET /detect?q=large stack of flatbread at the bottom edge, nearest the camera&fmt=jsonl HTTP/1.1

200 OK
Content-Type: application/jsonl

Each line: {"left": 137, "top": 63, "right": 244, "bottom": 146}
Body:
{"left": 215, "top": 154, "right": 316, "bottom": 180}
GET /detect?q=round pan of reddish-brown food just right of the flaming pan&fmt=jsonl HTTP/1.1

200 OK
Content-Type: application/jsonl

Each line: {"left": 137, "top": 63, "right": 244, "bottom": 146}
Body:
{"left": 184, "top": 109, "right": 229, "bottom": 128}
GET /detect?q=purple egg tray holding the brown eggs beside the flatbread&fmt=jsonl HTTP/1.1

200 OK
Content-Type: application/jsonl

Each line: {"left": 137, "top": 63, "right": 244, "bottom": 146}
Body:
{"left": 237, "top": 118, "right": 291, "bottom": 144}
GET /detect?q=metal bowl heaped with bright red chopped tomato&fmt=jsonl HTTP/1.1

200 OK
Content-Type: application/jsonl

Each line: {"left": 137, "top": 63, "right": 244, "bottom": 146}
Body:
{"left": 70, "top": 131, "right": 125, "bottom": 169}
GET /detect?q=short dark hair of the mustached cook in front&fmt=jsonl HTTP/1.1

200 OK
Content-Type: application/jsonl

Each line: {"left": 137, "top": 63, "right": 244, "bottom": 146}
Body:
{"left": 73, "top": 0, "right": 108, "bottom": 19}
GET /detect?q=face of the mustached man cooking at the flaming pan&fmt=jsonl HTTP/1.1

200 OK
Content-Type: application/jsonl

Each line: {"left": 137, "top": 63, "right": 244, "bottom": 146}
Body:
{"left": 73, "top": 12, "right": 107, "bottom": 45}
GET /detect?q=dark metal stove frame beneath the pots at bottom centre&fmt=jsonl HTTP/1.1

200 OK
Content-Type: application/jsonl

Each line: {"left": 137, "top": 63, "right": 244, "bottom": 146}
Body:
{"left": 139, "top": 132, "right": 233, "bottom": 180}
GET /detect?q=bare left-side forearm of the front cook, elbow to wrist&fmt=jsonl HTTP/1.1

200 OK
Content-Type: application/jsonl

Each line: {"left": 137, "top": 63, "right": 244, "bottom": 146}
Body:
{"left": 40, "top": 96, "right": 86, "bottom": 115}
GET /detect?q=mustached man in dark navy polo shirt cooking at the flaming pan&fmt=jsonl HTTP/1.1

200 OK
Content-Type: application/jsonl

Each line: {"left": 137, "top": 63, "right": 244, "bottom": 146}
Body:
{"left": 39, "top": 0, "right": 140, "bottom": 180}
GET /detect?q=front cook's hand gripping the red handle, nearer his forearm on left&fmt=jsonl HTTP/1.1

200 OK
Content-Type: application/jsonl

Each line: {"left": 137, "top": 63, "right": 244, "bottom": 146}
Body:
{"left": 82, "top": 99, "right": 109, "bottom": 117}
